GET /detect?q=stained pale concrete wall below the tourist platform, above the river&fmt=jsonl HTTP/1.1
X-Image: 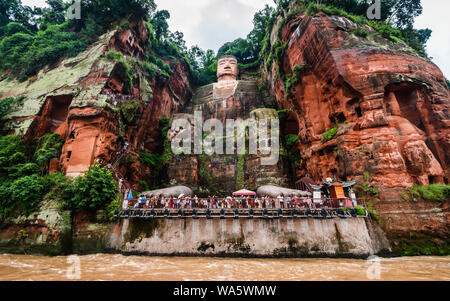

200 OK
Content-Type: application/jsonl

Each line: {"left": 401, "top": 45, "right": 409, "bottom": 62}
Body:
{"left": 108, "top": 218, "right": 390, "bottom": 257}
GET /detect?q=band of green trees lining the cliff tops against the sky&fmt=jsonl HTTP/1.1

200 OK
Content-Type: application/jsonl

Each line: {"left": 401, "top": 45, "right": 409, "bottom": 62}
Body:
{"left": 0, "top": 0, "right": 431, "bottom": 88}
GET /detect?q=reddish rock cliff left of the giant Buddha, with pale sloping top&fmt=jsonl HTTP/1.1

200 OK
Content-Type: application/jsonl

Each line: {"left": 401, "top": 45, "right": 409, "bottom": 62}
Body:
{"left": 0, "top": 22, "right": 192, "bottom": 188}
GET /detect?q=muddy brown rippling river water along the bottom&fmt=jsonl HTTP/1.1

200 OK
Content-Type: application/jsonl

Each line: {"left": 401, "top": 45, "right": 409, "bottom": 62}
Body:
{"left": 0, "top": 254, "right": 450, "bottom": 281}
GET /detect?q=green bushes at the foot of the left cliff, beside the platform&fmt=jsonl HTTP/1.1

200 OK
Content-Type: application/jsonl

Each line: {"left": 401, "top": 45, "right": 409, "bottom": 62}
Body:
{"left": 0, "top": 134, "right": 118, "bottom": 219}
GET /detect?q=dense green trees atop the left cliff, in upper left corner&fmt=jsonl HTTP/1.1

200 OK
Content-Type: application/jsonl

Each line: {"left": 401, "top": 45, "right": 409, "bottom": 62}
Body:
{"left": 0, "top": 0, "right": 156, "bottom": 80}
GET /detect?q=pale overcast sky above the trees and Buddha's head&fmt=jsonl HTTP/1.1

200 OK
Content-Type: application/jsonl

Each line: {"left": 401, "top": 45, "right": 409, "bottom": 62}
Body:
{"left": 22, "top": 0, "right": 450, "bottom": 79}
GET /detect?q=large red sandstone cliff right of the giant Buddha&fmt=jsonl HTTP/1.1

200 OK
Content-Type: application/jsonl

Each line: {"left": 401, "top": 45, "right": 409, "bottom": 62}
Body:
{"left": 265, "top": 7, "right": 450, "bottom": 237}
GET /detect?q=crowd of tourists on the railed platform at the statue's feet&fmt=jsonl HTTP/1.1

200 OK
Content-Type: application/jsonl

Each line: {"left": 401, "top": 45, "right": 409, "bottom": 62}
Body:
{"left": 125, "top": 196, "right": 357, "bottom": 209}
